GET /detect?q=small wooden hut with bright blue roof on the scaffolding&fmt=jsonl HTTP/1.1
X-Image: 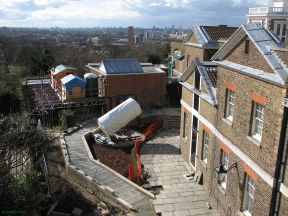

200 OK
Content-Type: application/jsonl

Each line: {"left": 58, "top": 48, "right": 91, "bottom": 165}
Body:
{"left": 61, "top": 74, "right": 86, "bottom": 101}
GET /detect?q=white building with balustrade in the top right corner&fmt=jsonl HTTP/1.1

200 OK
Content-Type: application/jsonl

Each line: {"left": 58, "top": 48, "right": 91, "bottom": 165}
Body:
{"left": 247, "top": 0, "right": 288, "bottom": 41}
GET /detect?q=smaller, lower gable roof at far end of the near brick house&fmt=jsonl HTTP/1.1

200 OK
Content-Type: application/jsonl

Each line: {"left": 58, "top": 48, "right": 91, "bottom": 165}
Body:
{"left": 178, "top": 58, "right": 218, "bottom": 106}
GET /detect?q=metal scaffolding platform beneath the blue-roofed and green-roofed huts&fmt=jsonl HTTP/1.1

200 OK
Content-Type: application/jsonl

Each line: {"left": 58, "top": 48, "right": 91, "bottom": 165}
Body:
{"left": 25, "top": 78, "right": 110, "bottom": 126}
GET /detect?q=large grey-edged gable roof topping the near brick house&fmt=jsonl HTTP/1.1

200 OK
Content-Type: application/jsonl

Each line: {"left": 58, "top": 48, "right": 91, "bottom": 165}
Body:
{"left": 212, "top": 23, "right": 288, "bottom": 85}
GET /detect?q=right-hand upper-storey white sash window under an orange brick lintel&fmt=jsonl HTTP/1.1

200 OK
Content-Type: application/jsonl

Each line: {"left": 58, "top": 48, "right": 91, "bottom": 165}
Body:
{"left": 251, "top": 102, "right": 265, "bottom": 142}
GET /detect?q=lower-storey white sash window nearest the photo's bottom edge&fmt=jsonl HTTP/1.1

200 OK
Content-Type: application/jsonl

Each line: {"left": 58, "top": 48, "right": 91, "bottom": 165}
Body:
{"left": 243, "top": 174, "right": 255, "bottom": 216}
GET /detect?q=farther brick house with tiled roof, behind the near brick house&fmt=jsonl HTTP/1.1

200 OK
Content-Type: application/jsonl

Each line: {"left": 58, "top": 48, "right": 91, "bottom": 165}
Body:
{"left": 171, "top": 25, "right": 237, "bottom": 76}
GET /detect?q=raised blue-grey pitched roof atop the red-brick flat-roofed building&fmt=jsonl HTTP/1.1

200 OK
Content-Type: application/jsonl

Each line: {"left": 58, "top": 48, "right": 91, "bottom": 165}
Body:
{"left": 100, "top": 59, "right": 143, "bottom": 74}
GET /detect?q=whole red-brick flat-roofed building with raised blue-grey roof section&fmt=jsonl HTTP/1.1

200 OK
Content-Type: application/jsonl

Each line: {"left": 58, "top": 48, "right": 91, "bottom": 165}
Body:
{"left": 85, "top": 59, "right": 166, "bottom": 108}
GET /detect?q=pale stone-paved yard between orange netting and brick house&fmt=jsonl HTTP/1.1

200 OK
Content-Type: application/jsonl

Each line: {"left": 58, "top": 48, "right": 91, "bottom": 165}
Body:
{"left": 141, "top": 130, "right": 219, "bottom": 216}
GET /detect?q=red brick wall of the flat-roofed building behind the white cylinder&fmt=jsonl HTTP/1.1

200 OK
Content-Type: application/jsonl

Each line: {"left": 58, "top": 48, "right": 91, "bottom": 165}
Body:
{"left": 105, "top": 73, "right": 166, "bottom": 107}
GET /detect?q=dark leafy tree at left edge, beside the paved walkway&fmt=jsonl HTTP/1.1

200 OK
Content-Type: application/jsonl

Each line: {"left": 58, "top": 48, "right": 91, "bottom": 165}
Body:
{"left": 0, "top": 115, "right": 51, "bottom": 209}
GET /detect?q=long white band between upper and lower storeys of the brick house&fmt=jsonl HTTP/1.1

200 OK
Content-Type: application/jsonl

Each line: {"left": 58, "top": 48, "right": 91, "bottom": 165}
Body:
{"left": 181, "top": 100, "right": 274, "bottom": 189}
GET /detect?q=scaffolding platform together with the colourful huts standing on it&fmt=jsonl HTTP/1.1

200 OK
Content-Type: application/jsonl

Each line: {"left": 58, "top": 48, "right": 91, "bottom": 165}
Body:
{"left": 25, "top": 66, "right": 110, "bottom": 126}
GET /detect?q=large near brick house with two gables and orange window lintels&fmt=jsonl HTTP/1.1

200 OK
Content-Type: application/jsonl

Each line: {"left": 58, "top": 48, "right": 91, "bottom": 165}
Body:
{"left": 179, "top": 24, "right": 288, "bottom": 215}
